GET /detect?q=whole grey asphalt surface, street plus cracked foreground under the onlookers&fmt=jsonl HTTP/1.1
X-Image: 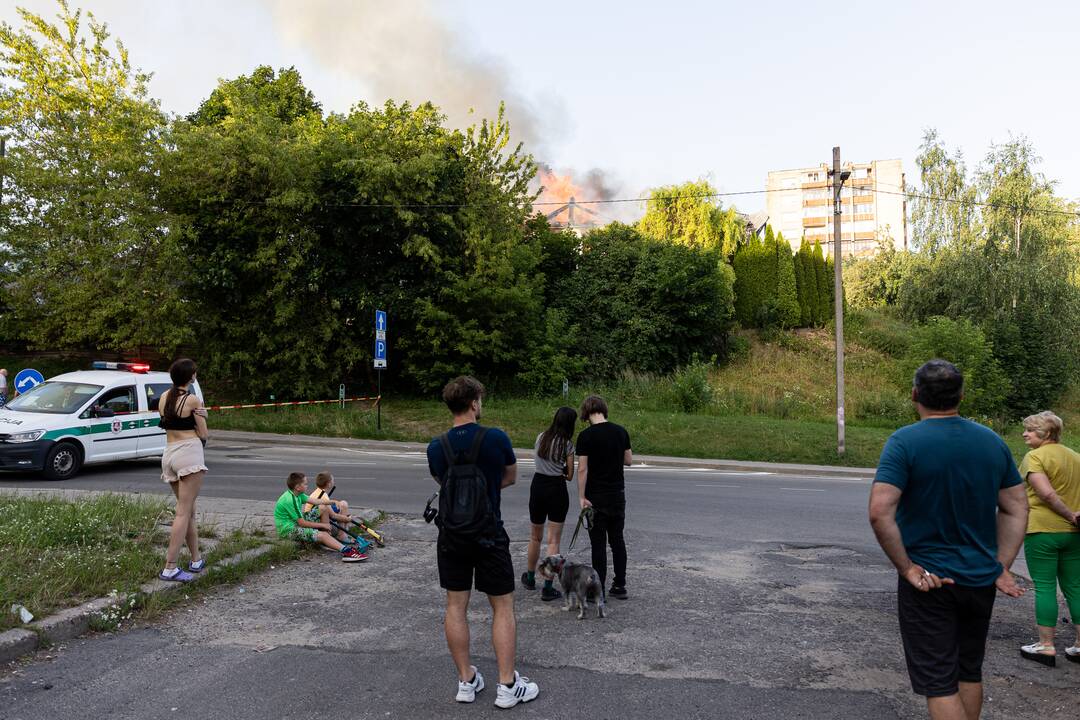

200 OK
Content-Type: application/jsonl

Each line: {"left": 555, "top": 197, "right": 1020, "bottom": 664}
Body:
{"left": 0, "top": 441, "right": 1080, "bottom": 720}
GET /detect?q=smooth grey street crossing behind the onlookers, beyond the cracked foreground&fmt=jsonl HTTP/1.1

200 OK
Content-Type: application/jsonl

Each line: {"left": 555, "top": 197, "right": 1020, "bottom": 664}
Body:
{"left": 0, "top": 443, "right": 873, "bottom": 547}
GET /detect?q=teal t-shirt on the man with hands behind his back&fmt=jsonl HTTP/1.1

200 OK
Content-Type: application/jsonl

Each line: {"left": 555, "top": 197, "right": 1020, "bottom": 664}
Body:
{"left": 874, "top": 417, "right": 1023, "bottom": 587}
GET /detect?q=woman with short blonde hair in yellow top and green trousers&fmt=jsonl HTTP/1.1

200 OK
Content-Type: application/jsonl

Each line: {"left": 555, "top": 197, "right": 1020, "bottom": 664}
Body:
{"left": 1020, "top": 411, "right": 1080, "bottom": 666}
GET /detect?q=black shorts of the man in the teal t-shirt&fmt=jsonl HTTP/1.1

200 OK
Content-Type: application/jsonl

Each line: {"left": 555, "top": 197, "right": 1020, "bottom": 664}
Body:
{"left": 896, "top": 578, "right": 996, "bottom": 697}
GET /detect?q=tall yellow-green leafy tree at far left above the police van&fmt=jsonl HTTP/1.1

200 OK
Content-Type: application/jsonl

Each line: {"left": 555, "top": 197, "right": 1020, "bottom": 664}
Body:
{"left": 0, "top": 1, "right": 184, "bottom": 352}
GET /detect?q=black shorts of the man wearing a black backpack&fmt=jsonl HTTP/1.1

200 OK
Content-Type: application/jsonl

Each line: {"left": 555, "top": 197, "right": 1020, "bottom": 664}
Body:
{"left": 436, "top": 528, "right": 514, "bottom": 595}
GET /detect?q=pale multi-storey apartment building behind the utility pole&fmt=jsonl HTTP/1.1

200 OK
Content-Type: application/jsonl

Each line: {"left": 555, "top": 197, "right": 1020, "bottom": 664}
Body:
{"left": 766, "top": 160, "right": 907, "bottom": 256}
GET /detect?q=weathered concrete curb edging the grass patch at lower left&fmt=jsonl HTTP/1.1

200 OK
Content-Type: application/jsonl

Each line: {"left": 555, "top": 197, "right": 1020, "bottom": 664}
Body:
{"left": 0, "top": 543, "right": 274, "bottom": 663}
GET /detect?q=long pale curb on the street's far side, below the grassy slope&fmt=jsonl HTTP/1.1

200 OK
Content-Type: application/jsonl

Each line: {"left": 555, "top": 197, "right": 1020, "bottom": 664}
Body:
{"left": 214, "top": 430, "right": 876, "bottom": 479}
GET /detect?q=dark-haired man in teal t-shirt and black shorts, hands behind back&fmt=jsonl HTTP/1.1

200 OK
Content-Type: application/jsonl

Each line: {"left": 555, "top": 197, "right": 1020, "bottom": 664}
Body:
{"left": 869, "top": 359, "right": 1027, "bottom": 718}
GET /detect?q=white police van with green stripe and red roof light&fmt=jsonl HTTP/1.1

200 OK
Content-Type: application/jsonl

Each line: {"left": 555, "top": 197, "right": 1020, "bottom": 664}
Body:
{"left": 0, "top": 362, "right": 202, "bottom": 480}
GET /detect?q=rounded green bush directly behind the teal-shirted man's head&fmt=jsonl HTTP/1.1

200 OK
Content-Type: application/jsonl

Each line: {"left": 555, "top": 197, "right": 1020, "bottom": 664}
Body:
{"left": 904, "top": 317, "right": 1010, "bottom": 418}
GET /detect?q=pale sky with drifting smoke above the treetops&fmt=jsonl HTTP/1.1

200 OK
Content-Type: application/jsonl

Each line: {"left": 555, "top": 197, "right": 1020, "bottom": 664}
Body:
{"left": 0, "top": 0, "right": 1080, "bottom": 212}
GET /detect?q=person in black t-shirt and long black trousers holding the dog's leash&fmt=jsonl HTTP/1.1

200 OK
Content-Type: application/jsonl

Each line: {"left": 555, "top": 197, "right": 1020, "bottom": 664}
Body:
{"left": 578, "top": 395, "right": 633, "bottom": 600}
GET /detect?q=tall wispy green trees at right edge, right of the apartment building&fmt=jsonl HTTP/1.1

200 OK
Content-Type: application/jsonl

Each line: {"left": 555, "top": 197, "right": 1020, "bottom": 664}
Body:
{"left": 898, "top": 132, "right": 1080, "bottom": 418}
